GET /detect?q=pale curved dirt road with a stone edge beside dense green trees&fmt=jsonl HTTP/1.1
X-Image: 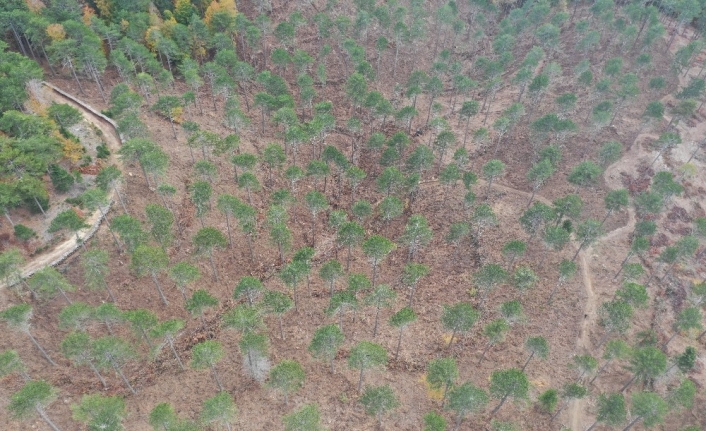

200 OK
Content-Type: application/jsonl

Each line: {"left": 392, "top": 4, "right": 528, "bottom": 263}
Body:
{"left": 0, "top": 82, "right": 122, "bottom": 288}
